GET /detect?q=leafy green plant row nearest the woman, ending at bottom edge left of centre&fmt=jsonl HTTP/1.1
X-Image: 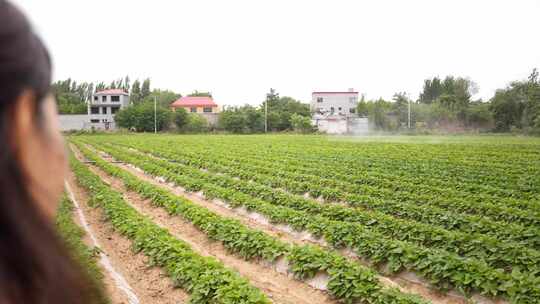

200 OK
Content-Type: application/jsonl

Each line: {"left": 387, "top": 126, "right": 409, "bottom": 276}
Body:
{"left": 70, "top": 156, "right": 270, "bottom": 304}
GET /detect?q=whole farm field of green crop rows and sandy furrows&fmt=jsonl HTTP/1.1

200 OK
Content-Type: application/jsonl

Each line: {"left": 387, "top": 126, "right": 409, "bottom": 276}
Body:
{"left": 67, "top": 135, "right": 540, "bottom": 303}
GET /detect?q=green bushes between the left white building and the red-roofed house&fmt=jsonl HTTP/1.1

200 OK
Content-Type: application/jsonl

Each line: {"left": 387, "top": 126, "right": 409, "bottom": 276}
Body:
{"left": 114, "top": 102, "right": 174, "bottom": 132}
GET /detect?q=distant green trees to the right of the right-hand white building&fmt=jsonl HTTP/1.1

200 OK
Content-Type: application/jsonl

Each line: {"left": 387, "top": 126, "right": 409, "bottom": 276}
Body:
{"left": 357, "top": 69, "right": 540, "bottom": 133}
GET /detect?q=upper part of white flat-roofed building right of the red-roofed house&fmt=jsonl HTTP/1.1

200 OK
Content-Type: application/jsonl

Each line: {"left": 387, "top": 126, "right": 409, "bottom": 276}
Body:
{"left": 311, "top": 89, "right": 358, "bottom": 117}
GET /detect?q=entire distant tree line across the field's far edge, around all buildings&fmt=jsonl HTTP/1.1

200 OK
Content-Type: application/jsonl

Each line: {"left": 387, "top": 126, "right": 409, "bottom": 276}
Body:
{"left": 57, "top": 69, "right": 540, "bottom": 134}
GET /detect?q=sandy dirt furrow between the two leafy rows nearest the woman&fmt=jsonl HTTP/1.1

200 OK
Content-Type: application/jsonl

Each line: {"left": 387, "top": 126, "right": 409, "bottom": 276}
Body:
{"left": 70, "top": 145, "right": 337, "bottom": 304}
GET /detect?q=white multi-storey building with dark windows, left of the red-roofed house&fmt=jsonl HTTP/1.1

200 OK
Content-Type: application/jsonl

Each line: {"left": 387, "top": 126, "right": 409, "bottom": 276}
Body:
{"left": 88, "top": 89, "right": 129, "bottom": 130}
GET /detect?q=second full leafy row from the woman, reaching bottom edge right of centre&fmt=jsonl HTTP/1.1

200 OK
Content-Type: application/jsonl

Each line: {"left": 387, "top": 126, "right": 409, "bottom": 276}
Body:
{"left": 71, "top": 141, "right": 427, "bottom": 304}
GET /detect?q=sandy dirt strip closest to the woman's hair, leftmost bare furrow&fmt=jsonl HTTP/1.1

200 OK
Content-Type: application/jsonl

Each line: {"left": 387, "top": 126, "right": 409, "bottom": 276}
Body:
{"left": 67, "top": 172, "right": 189, "bottom": 304}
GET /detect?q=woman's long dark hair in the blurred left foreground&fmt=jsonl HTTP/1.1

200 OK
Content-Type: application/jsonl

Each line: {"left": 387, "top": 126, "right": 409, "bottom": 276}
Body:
{"left": 0, "top": 0, "right": 104, "bottom": 304}
